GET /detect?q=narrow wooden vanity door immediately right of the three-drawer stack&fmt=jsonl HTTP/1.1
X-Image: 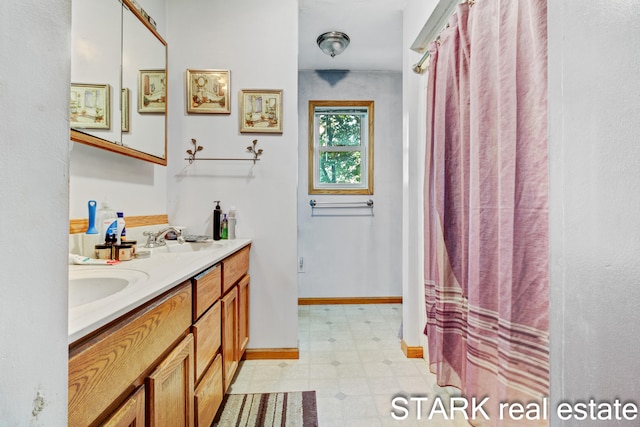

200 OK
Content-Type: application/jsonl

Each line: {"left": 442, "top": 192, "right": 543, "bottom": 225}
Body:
{"left": 221, "top": 286, "right": 238, "bottom": 393}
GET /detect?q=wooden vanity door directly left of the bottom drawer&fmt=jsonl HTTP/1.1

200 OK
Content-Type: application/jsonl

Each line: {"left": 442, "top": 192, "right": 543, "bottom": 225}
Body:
{"left": 147, "top": 334, "right": 194, "bottom": 427}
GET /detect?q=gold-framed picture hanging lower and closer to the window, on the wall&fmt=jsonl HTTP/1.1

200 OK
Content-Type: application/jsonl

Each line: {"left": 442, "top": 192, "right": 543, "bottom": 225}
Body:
{"left": 240, "top": 89, "right": 282, "bottom": 133}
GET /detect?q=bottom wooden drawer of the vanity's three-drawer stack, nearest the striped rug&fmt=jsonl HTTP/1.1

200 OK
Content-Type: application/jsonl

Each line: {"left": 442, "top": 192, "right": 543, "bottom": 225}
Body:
{"left": 195, "top": 355, "right": 224, "bottom": 427}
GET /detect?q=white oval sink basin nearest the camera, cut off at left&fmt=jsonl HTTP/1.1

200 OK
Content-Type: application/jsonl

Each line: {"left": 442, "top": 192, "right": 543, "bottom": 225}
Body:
{"left": 69, "top": 267, "right": 149, "bottom": 307}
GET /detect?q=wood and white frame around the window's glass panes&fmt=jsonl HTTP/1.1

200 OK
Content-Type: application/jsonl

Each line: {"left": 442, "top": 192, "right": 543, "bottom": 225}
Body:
{"left": 308, "top": 100, "right": 374, "bottom": 195}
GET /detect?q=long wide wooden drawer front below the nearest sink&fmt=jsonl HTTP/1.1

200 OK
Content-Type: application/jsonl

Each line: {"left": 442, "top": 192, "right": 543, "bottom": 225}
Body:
{"left": 68, "top": 282, "right": 193, "bottom": 426}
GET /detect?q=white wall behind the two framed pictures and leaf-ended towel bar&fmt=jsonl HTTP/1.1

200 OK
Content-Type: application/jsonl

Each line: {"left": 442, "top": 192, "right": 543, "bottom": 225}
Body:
{"left": 167, "top": 0, "right": 298, "bottom": 348}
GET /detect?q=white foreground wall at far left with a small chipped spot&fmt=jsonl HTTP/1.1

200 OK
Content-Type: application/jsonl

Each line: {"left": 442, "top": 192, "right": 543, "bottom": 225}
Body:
{"left": 0, "top": 0, "right": 71, "bottom": 426}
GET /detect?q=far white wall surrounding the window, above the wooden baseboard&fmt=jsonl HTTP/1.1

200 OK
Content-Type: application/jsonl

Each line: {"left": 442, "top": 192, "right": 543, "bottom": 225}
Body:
{"left": 297, "top": 71, "right": 402, "bottom": 298}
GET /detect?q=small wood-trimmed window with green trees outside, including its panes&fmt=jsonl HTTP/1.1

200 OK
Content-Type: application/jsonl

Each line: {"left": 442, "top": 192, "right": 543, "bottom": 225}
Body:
{"left": 309, "top": 101, "right": 373, "bottom": 194}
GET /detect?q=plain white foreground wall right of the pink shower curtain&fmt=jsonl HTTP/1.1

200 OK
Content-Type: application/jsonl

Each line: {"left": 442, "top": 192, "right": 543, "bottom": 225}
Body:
{"left": 548, "top": 1, "right": 640, "bottom": 426}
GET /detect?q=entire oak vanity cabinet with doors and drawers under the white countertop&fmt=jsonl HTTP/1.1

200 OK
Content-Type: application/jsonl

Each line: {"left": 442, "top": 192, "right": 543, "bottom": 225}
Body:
{"left": 68, "top": 246, "right": 250, "bottom": 427}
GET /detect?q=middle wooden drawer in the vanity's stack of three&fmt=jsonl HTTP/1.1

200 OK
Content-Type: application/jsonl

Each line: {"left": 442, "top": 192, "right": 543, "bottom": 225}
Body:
{"left": 193, "top": 302, "right": 222, "bottom": 382}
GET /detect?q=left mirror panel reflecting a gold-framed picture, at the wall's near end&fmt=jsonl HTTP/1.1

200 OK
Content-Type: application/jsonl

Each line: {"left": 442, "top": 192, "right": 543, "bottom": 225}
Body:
{"left": 69, "top": 0, "right": 122, "bottom": 145}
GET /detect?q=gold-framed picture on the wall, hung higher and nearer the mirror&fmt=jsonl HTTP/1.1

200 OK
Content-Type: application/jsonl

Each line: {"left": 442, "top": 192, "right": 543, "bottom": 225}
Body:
{"left": 187, "top": 68, "right": 231, "bottom": 114}
